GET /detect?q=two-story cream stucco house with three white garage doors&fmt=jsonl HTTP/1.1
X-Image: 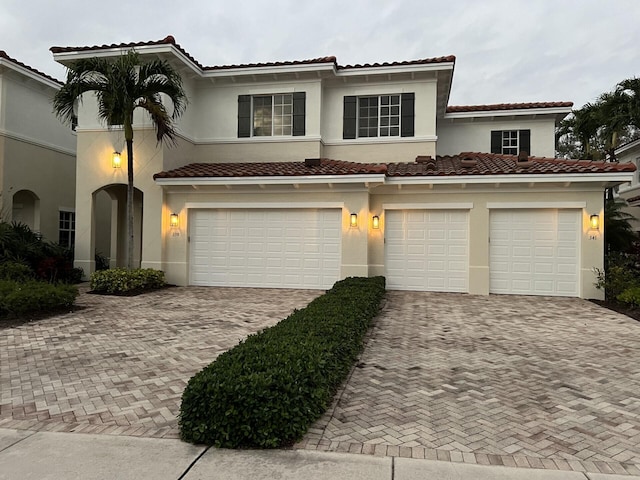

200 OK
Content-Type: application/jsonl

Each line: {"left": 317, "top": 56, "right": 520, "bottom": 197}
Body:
{"left": 52, "top": 37, "right": 634, "bottom": 298}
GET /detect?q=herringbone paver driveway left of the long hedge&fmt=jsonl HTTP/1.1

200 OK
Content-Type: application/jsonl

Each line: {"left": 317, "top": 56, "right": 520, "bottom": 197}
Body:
{"left": 0, "top": 287, "right": 321, "bottom": 437}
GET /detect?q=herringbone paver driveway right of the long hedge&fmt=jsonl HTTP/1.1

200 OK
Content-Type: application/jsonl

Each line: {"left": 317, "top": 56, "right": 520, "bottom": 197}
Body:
{"left": 298, "top": 292, "right": 640, "bottom": 474}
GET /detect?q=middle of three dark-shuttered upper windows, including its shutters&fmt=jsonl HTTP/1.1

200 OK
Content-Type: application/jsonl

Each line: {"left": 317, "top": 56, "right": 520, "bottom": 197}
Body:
{"left": 342, "top": 93, "right": 415, "bottom": 139}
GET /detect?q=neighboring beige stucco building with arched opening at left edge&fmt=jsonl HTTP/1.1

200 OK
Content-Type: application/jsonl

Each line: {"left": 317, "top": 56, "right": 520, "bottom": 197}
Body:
{"left": 0, "top": 51, "right": 76, "bottom": 246}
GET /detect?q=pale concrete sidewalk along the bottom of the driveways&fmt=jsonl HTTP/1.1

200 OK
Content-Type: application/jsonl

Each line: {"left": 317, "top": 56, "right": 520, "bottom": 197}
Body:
{"left": 0, "top": 429, "right": 640, "bottom": 480}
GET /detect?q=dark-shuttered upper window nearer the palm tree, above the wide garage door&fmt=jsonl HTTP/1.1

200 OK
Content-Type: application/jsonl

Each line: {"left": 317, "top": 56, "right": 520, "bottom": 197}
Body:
{"left": 238, "top": 92, "right": 306, "bottom": 138}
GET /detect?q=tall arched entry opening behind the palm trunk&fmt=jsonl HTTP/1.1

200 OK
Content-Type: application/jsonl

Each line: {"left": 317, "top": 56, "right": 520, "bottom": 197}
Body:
{"left": 93, "top": 185, "right": 144, "bottom": 269}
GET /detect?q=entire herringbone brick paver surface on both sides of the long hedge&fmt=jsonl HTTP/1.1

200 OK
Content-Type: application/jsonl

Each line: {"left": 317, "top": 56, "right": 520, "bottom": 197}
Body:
{"left": 0, "top": 287, "right": 640, "bottom": 474}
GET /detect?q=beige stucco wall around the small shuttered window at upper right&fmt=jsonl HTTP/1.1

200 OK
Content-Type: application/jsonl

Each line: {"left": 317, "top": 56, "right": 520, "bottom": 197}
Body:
{"left": 437, "top": 117, "right": 556, "bottom": 158}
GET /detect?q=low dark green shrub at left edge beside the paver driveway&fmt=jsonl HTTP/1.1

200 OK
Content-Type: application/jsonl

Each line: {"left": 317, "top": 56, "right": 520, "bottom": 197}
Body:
{"left": 0, "top": 280, "right": 78, "bottom": 316}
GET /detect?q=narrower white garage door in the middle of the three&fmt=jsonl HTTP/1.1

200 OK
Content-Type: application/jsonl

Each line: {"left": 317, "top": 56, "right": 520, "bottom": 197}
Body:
{"left": 385, "top": 210, "right": 469, "bottom": 292}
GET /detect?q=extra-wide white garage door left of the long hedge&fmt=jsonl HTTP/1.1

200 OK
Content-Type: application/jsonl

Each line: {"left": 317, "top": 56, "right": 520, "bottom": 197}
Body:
{"left": 190, "top": 209, "right": 342, "bottom": 288}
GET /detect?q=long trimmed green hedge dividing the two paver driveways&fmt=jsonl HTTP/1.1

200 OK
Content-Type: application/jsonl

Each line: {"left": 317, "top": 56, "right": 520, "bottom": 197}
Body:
{"left": 179, "top": 277, "right": 385, "bottom": 448}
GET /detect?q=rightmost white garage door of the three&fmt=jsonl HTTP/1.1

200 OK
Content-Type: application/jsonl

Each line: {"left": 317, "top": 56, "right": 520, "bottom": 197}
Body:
{"left": 489, "top": 209, "right": 582, "bottom": 297}
